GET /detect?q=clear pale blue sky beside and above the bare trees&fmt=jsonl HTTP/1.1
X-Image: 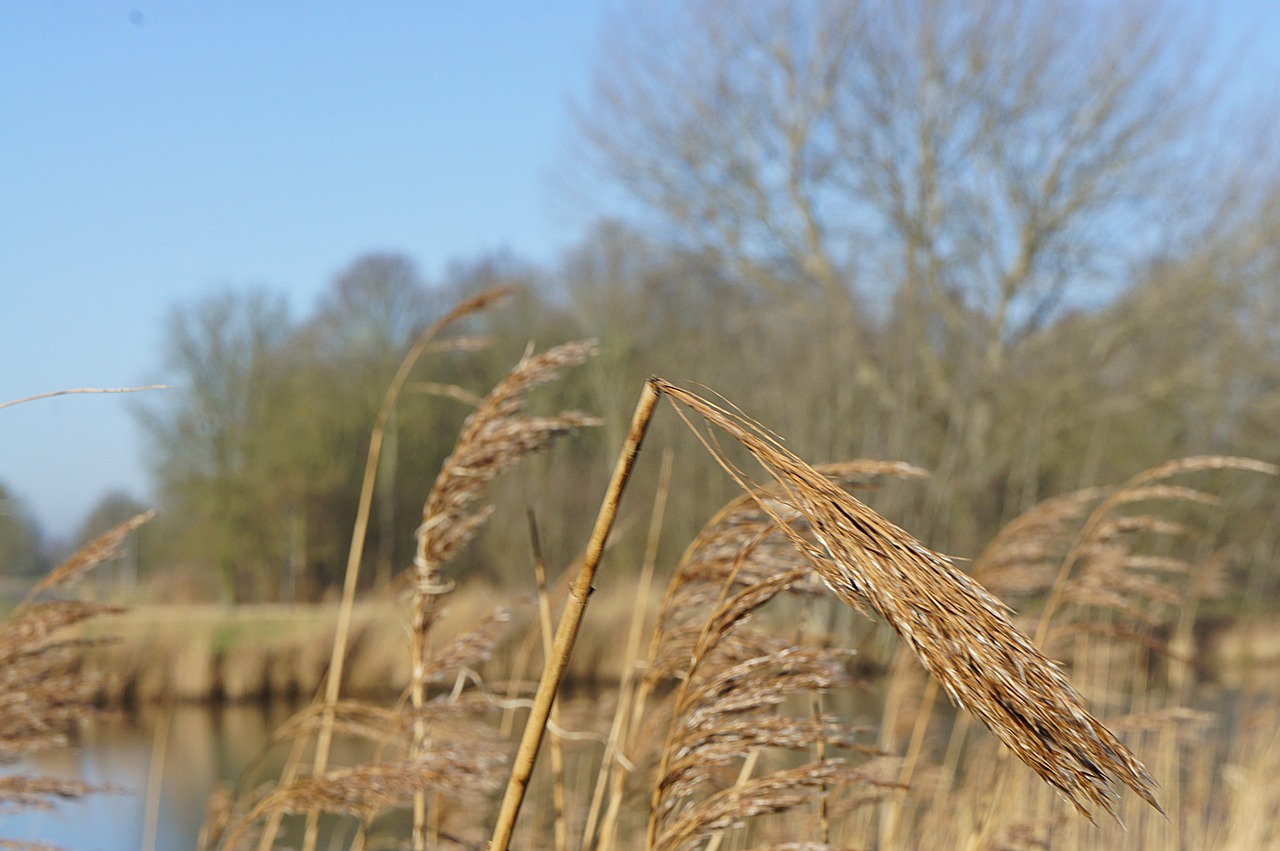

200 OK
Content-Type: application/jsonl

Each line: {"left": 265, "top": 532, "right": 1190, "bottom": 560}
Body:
{"left": 0, "top": 0, "right": 1280, "bottom": 545}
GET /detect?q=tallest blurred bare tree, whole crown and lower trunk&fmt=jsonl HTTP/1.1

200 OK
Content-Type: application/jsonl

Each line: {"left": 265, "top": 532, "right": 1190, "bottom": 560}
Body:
{"left": 577, "top": 0, "right": 1275, "bottom": 547}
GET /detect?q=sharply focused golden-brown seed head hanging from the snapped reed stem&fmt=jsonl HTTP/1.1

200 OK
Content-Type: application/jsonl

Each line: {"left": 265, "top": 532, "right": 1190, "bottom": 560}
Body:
{"left": 657, "top": 379, "right": 1160, "bottom": 819}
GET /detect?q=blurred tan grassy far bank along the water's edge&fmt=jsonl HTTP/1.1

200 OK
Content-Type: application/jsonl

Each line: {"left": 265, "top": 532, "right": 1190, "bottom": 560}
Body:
{"left": 72, "top": 586, "right": 1280, "bottom": 706}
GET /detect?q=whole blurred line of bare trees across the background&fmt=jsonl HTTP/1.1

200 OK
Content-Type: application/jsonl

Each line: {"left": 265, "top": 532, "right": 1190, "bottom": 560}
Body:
{"left": 2, "top": 0, "right": 1280, "bottom": 598}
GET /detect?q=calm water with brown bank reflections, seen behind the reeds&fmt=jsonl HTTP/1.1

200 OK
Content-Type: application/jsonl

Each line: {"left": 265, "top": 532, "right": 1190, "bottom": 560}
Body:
{"left": 0, "top": 682, "right": 1254, "bottom": 851}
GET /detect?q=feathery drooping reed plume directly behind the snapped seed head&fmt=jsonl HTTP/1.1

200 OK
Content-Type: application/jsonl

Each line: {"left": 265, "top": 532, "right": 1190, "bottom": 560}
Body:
{"left": 646, "top": 461, "right": 919, "bottom": 850}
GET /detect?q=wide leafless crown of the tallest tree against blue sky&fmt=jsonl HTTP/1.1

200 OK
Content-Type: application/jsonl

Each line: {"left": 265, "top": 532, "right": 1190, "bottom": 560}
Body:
{"left": 577, "top": 0, "right": 1254, "bottom": 345}
